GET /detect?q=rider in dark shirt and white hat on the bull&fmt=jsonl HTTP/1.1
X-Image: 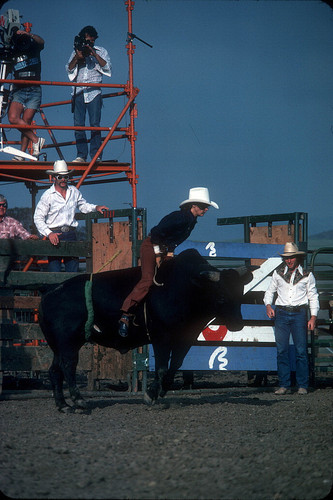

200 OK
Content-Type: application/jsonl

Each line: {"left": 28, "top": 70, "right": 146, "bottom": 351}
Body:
{"left": 119, "top": 187, "right": 219, "bottom": 337}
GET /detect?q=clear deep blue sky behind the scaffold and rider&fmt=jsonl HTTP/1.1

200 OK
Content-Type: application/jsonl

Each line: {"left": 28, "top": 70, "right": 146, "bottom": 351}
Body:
{"left": 0, "top": 0, "right": 333, "bottom": 241}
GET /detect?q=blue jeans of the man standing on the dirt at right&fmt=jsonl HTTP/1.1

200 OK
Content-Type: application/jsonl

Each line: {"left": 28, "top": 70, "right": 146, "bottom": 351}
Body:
{"left": 275, "top": 307, "right": 309, "bottom": 389}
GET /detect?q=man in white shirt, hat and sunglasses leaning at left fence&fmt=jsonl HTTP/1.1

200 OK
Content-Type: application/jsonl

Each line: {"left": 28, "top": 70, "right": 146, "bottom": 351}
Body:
{"left": 34, "top": 160, "right": 109, "bottom": 272}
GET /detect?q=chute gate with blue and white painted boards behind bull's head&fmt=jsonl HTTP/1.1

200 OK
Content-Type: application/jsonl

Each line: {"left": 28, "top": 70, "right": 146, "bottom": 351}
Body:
{"left": 162, "top": 212, "right": 333, "bottom": 383}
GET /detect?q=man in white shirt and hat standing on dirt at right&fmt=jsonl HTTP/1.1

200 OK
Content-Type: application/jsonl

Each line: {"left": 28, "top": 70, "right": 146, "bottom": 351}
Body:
{"left": 264, "top": 242, "right": 319, "bottom": 395}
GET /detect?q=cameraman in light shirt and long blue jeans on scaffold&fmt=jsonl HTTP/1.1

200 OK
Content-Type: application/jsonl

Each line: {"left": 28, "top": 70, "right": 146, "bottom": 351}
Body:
{"left": 66, "top": 26, "right": 111, "bottom": 163}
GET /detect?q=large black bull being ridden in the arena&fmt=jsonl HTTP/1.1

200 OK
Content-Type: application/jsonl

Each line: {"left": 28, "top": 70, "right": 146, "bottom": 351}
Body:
{"left": 39, "top": 249, "right": 252, "bottom": 411}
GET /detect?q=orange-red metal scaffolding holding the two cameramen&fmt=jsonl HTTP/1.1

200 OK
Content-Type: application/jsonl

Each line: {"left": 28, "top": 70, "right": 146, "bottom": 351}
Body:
{"left": 0, "top": 0, "right": 139, "bottom": 209}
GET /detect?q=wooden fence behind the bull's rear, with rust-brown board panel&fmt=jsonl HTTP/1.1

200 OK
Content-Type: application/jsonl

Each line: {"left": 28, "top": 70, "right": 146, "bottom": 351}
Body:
{"left": 0, "top": 209, "right": 145, "bottom": 391}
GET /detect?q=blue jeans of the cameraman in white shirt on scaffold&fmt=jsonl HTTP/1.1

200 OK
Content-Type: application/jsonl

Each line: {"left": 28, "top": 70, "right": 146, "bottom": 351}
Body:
{"left": 74, "top": 92, "right": 102, "bottom": 159}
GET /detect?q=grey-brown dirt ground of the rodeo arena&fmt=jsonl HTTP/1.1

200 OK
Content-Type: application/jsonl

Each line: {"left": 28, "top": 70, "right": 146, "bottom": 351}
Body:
{"left": 0, "top": 372, "right": 333, "bottom": 500}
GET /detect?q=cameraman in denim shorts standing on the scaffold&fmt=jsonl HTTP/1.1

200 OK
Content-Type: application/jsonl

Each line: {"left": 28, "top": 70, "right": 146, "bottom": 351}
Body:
{"left": 8, "top": 30, "right": 45, "bottom": 161}
